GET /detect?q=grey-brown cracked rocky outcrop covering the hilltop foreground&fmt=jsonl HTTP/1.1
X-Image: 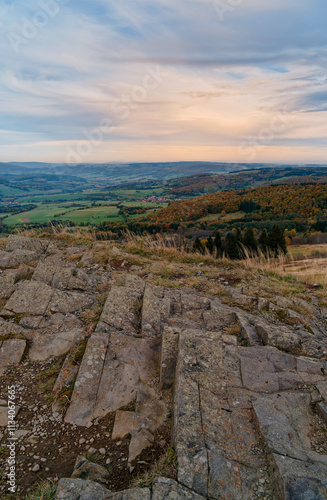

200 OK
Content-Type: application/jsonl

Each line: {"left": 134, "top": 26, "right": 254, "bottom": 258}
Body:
{"left": 0, "top": 236, "right": 327, "bottom": 500}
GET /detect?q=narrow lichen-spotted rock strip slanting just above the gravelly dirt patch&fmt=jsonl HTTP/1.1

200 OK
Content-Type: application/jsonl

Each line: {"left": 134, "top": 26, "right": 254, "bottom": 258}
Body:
{"left": 65, "top": 333, "right": 109, "bottom": 426}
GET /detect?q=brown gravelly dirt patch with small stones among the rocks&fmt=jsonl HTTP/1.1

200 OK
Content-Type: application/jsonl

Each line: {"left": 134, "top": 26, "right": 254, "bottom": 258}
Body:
{"left": 0, "top": 359, "right": 171, "bottom": 499}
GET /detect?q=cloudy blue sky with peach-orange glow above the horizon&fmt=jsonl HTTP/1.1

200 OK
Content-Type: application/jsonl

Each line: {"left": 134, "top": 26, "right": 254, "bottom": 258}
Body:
{"left": 0, "top": 0, "right": 327, "bottom": 163}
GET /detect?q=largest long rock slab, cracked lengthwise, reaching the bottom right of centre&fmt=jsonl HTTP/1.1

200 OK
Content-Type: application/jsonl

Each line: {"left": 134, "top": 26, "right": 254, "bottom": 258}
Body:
{"left": 174, "top": 329, "right": 272, "bottom": 500}
